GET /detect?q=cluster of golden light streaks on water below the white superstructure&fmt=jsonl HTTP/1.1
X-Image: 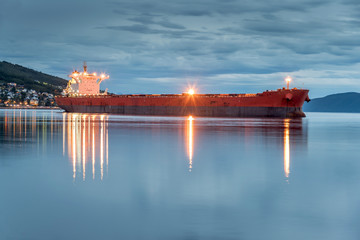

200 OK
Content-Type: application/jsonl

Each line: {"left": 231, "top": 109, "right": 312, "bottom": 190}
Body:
{"left": 63, "top": 113, "right": 109, "bottom": 180}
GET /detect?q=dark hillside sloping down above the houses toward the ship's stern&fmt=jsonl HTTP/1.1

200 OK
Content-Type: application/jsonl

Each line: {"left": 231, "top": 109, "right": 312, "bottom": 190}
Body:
{"left": 0, "top": 61, "right": 67, "bottom": 94}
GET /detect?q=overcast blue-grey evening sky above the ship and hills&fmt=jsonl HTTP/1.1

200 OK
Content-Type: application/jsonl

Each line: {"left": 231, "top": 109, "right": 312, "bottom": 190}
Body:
{"left": 0, "top": 0, "right": 360, "bottom": 97}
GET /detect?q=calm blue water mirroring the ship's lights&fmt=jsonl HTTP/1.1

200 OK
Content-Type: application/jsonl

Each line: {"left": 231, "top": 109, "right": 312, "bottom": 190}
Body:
{"left": 0, "top": 110, "right": 360, "bottom": 240}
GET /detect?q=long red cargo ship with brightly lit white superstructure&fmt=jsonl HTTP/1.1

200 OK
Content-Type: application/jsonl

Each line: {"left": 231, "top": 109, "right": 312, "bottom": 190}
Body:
{"left": 55, "top": 64, "right": 310, "bottom": 118}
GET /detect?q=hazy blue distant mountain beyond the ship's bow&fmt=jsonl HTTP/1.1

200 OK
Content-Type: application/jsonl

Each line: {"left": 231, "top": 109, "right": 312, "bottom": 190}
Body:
{"left": 303, "top": 92, "right": 360, "bottom": 113}
